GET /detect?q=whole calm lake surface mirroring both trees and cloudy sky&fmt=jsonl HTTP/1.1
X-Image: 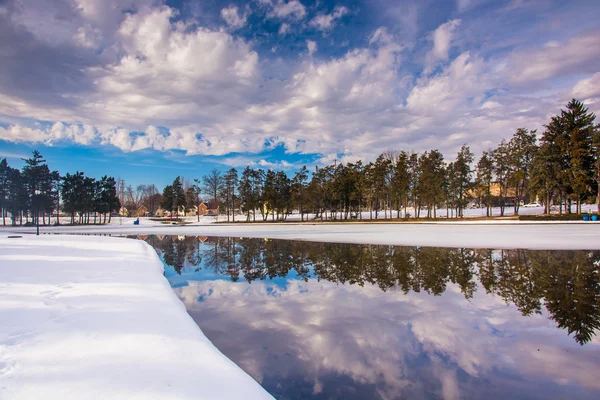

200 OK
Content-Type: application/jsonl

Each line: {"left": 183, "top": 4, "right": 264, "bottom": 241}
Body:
{"left": 134, "top": 236, "right": 600, "bottom": 399}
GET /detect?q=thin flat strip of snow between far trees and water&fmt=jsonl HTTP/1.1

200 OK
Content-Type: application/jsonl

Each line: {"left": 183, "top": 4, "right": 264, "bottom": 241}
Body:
{"left": 0, "top": 221, "right": 600, "bottom": 250}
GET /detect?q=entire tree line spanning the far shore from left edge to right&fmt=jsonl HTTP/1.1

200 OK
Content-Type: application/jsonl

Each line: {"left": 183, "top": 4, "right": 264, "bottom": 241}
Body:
{"left": 0, "top": 99, "right": 600, "bottom": 224}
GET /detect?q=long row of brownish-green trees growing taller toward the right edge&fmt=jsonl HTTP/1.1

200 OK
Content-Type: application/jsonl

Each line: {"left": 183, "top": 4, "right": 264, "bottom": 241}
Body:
{"left": 158, "top": 99, "right": 600, "bottom": 221}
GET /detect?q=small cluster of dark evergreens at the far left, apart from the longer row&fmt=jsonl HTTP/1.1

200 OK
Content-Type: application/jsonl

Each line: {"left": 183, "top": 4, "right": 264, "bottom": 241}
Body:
{"left": 0, "top": 151, "right": 121, "bottom": 225}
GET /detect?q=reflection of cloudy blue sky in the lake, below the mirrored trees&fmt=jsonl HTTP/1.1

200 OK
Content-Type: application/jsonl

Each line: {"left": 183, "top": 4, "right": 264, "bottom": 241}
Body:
{"left": 154, "top": 241, "right": 600, "bottom": 399}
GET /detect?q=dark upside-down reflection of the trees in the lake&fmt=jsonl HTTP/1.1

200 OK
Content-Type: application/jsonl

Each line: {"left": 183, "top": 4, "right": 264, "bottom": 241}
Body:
{"left": 138, "top": 236, "right": 600, "bottom": 344}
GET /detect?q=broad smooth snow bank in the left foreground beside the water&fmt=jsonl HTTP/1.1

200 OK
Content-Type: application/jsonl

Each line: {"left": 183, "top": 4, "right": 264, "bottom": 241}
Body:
{"left": 0, "top": 235, "right": 272, "bottom": 400}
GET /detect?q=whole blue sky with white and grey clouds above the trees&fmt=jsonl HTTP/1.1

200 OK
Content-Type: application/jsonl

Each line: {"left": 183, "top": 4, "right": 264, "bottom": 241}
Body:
{"left": 0, "top": 0, "right": 600, "bottom": 186}
